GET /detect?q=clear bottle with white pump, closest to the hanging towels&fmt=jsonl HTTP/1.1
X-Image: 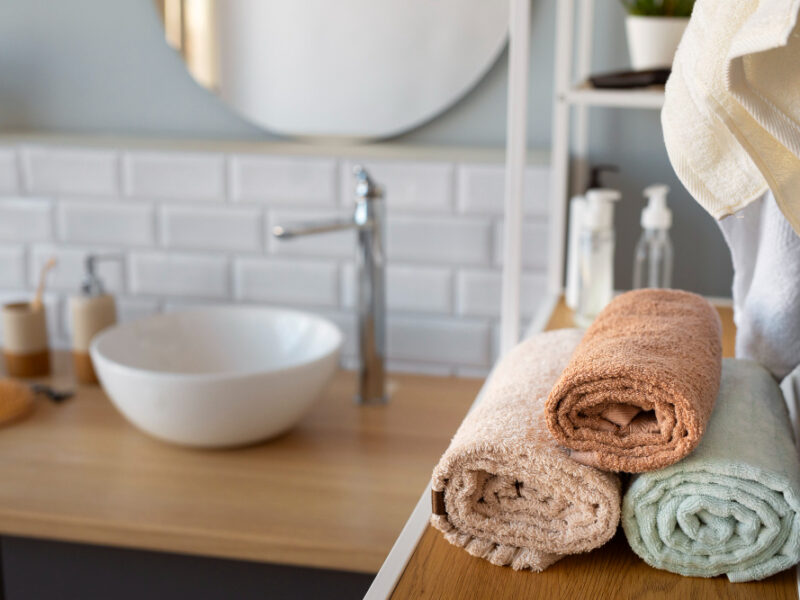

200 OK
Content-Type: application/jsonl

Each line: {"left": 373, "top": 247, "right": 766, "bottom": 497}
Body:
{"left": 633, "top": 184, "right": 672, "bottom": 289}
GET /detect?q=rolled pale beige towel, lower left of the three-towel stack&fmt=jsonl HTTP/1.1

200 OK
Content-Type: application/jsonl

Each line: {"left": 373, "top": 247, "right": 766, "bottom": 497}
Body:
{"left": 431, "top": 329, "right": 621, "bottom": 571}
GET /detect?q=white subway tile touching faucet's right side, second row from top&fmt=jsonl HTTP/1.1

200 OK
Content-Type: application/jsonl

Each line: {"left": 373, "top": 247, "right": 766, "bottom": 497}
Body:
{"left": 387, "top": 216, "right": 492, "bottom": 265}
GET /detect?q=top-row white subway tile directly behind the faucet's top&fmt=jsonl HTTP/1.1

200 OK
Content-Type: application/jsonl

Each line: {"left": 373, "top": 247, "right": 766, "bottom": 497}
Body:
{"left": 341, "top": 161, "right": 454, "bottom": 212}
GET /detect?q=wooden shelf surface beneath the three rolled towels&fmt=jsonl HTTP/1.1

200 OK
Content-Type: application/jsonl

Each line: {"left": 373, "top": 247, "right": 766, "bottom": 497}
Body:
{"left": 390, "top": 301, "right": 798, "bottom": 600}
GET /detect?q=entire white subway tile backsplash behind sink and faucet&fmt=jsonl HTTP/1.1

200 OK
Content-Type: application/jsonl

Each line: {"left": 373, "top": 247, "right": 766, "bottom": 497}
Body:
{"left": 0, "top": 142, "right": 549, "bottom": 377}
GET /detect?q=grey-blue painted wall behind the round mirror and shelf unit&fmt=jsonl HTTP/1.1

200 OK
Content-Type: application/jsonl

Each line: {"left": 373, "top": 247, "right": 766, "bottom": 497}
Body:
{"left": 0, "top": 0, "right": 732, "bottom": 296}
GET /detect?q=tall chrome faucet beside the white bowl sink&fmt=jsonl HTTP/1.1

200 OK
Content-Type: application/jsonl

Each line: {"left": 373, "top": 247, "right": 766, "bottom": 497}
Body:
{"left": 272, "top": 166, "right": 388, "bottom": 404}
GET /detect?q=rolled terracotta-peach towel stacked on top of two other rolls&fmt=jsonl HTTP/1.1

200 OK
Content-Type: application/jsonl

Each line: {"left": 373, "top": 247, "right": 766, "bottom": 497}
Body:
{"left": 546, "top": 289, "right": 722, "bottom": 473}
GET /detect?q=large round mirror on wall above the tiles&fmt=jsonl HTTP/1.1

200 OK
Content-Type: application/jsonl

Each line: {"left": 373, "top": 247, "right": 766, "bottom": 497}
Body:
{"left": 155, "top": 0, "right": 508, "bottom": 139}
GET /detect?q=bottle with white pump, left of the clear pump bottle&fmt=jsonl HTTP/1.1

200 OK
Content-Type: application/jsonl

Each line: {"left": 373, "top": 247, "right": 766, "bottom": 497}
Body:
{"left": 575, "top": 188, "right": 621, "bottom": 327}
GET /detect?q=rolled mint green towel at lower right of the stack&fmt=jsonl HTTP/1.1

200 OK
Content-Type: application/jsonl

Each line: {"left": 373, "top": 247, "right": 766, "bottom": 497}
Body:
{"left": 622, "top": 359, "right": 800, "bottom": 582}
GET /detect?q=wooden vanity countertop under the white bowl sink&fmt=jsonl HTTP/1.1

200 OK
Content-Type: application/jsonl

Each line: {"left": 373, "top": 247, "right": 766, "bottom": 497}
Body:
{"left": 0, "top": 354, "right": 482, "bottom": 573}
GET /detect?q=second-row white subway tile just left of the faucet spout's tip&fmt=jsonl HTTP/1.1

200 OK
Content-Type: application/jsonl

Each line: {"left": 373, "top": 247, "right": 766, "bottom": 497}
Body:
{"left": 161, "top": 205, "right": 263, "bottom": 252}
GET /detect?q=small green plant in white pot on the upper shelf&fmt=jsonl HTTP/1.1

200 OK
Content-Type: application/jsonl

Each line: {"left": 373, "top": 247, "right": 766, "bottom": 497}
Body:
{"left": 621, "top": 0, "right": 694, "bottom": 71}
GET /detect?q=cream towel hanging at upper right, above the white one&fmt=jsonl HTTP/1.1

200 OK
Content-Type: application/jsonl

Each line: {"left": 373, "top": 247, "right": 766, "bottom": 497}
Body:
{"left": 661, "top": 0, "right": 800, "bottom": 232}
